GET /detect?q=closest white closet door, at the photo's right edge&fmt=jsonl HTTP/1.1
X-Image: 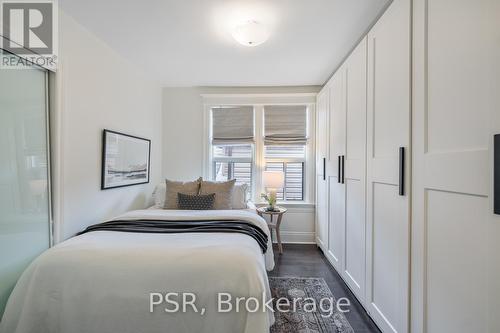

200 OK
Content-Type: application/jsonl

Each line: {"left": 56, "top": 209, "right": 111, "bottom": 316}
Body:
{"left": 412, "top": 0, "right": 500, "bottom": 333}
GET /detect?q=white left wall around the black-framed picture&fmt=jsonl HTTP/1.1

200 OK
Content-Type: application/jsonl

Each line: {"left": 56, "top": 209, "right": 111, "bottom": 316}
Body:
{"left": 52, "top": 11, "right": 162, "bottom": 241}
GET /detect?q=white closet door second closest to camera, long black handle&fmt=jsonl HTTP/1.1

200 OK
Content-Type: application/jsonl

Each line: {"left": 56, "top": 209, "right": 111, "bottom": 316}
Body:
{"left": 366, "top": 0, "right": 411, "bottom": 332}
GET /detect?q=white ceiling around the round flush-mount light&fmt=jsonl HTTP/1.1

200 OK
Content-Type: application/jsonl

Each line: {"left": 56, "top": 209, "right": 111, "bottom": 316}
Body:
{"left": 59, "top": 0, "right": 389, "bottom": 86}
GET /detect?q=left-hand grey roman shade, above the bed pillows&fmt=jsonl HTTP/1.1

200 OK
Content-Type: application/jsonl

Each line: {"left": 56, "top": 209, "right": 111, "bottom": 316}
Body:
{"left": 212, "top": 106, "right": 254, "bottom": 145}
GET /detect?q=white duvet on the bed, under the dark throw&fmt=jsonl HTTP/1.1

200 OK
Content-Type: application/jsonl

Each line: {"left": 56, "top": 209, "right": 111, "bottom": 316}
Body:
{"left": 0, "top": 209, "right": 274, "bottom": 333}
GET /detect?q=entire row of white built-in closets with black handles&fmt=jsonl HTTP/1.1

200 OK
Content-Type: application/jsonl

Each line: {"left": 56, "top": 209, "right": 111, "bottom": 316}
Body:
{"left": 316, "top": 0, "right": 500, "bottom": 333}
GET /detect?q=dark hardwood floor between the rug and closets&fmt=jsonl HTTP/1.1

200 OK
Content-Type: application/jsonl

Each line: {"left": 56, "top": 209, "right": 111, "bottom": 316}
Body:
{"left": 269, "top": 244, "right": 380, "bottom": 333}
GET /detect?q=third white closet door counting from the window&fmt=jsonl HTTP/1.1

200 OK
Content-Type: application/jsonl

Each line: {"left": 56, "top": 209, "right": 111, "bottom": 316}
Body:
{"left": 342, "top": 38, "right": 367, "bottom": 303}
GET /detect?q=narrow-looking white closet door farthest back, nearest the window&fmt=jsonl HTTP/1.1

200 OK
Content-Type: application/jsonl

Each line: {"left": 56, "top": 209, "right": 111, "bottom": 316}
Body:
{"left": 316, "top": 87, "right": 330, "bottom": 249}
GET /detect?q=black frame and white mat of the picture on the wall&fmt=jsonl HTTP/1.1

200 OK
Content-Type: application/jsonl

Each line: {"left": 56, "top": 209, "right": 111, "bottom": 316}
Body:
{"left": 101, "top": 129, "right": 151, "bottom": 190}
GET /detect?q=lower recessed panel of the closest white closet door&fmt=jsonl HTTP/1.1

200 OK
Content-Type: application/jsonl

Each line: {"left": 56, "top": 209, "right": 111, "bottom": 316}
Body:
{"left": 425, "top": 190, "right": 490, "bottom": 333}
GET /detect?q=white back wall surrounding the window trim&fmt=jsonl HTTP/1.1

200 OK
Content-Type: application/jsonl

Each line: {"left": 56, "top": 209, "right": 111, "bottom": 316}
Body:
{"left": 162, "top": 86, "right": 320, "bottom": 243}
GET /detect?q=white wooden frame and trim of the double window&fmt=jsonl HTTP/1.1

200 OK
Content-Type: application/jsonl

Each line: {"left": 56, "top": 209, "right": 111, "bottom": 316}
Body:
{"left": 201, "top": 93, "right": 316, "bottom": 204}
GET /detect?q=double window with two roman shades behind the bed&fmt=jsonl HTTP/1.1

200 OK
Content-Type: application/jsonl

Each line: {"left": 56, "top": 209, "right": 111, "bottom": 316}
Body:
{"left": 205, "top": 100, "right": 314, "bottom": 202}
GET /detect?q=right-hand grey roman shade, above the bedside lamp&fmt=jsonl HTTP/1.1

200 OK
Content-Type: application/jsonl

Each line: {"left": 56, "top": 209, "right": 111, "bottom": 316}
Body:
{"left": 264, "top": 105, "right": 307, "bottom": 145}
